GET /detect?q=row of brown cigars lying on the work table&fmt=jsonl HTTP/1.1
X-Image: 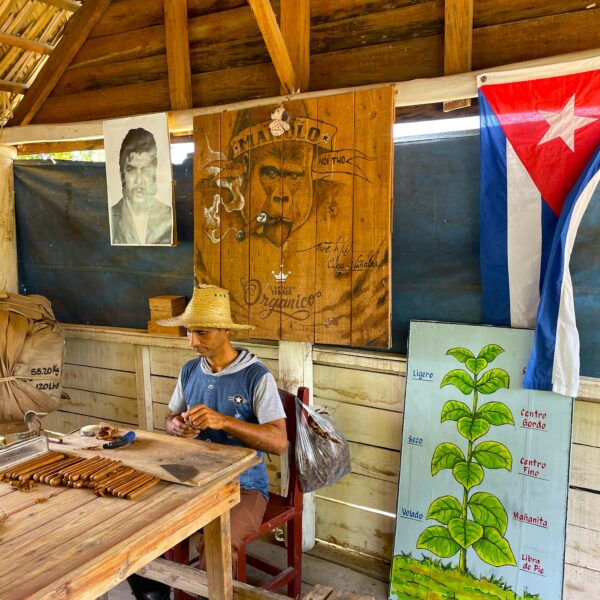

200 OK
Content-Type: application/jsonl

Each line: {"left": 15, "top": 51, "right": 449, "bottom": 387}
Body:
{"left": 0, "top": 451, "right": 160, "bottom": 500}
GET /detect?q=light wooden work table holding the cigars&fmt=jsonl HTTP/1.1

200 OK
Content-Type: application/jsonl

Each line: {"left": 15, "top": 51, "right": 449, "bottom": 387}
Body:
{"left": 0, "top": 432, "right": 260, "bottom": 600}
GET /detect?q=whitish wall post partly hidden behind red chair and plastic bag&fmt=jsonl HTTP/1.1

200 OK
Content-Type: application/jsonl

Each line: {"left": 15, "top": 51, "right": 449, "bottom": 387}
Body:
{"left": 278, "top": 340, "right": 315, "bottom": 552}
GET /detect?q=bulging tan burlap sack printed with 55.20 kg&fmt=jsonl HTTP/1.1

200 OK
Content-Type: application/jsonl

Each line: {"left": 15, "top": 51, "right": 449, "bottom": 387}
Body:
{"left": 0, "top": 291, "right": 65, "bottom": 432}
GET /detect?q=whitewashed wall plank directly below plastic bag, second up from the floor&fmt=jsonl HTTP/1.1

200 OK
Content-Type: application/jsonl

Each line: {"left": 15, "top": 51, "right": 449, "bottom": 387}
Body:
{"left": 316, "top": 473, "right": 398, "bottom": 518}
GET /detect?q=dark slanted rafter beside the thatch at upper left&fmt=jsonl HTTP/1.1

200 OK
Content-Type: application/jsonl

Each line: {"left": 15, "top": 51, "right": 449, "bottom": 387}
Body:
{"left": 9, "top": 0, "right": 111, "bottom": 125}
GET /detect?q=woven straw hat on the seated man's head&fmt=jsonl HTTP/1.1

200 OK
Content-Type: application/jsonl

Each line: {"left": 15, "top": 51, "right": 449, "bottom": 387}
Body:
{"left": 156, "top": 283, "right": 252, "bottom": 330}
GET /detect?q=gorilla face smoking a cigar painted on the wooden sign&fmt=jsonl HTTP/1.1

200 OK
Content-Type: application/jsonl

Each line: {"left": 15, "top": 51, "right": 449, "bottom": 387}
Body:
{"left": 250, "top": 141, "right": 313, "bottom": 246}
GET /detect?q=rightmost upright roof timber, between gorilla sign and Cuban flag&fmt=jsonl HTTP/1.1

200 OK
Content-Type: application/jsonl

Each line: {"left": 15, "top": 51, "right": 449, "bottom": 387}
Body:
{"left": 444, "top": 0, "right": 473, "bottom": 112}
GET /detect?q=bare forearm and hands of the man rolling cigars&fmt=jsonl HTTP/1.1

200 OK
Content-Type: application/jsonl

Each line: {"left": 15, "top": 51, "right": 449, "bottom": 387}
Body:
{"left": 180, "top": 404, "right": 288, "bottom": 454}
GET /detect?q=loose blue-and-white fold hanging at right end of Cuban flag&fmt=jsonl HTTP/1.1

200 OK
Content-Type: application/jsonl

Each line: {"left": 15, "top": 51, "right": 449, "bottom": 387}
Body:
{"left": 523, "top": 148, "right": 600, "bottom": 396}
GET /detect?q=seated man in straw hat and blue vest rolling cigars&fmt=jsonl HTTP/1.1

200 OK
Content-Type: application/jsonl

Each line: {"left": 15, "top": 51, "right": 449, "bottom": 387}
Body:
{"left": 165, "top": 285, "right": 287, "bottom": 578}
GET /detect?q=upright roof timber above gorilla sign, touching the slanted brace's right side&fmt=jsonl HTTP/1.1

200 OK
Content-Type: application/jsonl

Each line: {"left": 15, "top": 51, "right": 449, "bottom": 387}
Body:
{"left": 280, "top": 0, "right": 310, "bottom": 92}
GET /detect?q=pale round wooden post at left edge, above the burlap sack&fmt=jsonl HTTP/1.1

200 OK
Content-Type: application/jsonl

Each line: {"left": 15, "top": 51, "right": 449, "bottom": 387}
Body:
{"left": 0, "top": 146, "right": 19, "bottom": 294}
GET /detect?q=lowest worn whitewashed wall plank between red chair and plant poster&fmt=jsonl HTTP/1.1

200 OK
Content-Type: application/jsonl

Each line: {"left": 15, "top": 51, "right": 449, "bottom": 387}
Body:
{"left": 316, "top": 497, "right": 395, "bottom": 560}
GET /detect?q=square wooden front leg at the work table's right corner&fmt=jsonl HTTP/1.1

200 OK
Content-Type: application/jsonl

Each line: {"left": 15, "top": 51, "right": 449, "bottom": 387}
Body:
{"left": 204, "top": 511, "right": 233, "bottom": 600}
